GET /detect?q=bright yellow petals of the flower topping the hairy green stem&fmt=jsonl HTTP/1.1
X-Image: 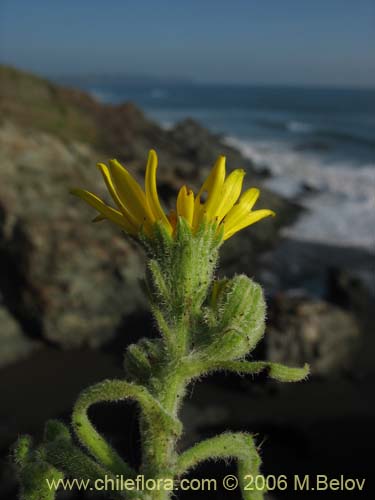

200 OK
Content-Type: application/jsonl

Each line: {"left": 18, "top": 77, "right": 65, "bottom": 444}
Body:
{"left": 72, "top": 150, "right": 275, "bottom": 240}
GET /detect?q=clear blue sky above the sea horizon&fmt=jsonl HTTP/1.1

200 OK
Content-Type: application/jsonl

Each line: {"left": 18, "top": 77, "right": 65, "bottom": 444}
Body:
{"left": 0, "top": 0, "right": 375, "bottom": 86}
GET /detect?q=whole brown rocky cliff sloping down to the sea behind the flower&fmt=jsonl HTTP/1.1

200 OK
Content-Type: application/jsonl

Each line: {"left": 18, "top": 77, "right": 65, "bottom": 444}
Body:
{"left": 0, "top": 67, "right": 298, "bottom": 365}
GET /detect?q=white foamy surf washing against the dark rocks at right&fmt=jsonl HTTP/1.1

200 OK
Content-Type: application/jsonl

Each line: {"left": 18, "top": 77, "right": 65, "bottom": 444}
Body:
{"left": 227, "top": 137, "right": 375, "bottom": 250}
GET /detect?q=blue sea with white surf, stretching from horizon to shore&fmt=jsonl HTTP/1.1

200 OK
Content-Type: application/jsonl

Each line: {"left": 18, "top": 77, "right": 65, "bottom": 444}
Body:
{"left": 76, "top": 81, "right": 375, "bottom": 249}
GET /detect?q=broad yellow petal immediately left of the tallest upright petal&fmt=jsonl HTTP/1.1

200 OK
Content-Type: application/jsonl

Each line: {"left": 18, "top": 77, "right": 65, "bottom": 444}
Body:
{"left": 109, "top": 160, "right": 155, "bottom": 228}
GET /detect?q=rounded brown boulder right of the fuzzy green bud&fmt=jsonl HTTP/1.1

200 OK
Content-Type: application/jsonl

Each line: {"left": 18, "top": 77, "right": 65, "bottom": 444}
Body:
{"left": 265, "top": 294, "right": 360, "bottom": 375}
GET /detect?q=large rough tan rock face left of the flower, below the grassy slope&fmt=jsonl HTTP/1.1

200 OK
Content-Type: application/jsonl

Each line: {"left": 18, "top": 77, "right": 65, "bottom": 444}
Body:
{"left": 0, "top": 124, "right": 143, "bottom": 347}
